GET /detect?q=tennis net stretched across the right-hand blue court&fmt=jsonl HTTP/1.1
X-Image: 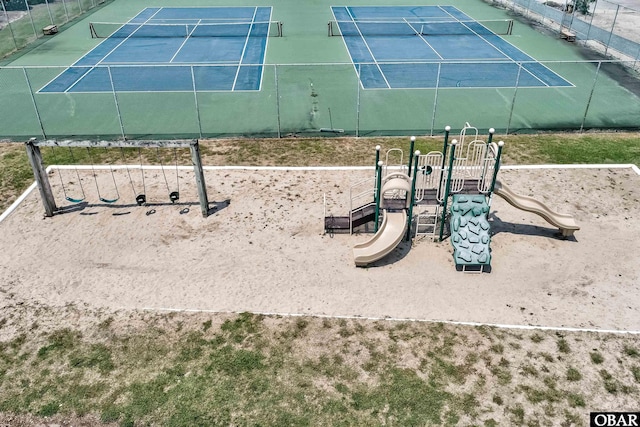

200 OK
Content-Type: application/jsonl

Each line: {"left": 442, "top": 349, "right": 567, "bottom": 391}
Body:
{"left": 328, "top": 19, "right": 513, "bottom": 37}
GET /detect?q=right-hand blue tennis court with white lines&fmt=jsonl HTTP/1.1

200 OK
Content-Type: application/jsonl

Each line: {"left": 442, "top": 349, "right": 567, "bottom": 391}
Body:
{"left": 332, "top": 6, "right": 572, "bottom": 89}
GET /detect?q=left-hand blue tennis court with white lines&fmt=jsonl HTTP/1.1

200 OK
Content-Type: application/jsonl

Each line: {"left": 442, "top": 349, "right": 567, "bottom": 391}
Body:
{"left": 40, "top": 7, "right": 271, "bottom": 92}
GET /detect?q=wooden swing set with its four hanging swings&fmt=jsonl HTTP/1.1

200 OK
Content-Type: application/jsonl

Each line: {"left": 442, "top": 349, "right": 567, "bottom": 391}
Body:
{"left": 26, "top": 138, "right": 209, "bottom": 217}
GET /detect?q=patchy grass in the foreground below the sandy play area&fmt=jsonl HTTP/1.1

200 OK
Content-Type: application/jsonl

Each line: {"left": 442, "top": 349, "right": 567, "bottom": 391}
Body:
{"left": 0, "top": 309, "right": 639, "bottom": 426}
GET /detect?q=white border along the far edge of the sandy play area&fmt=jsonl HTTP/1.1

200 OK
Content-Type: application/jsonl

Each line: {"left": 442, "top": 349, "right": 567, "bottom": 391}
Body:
{"left": 0, "top": 164, "right": 640, "bottom": 222}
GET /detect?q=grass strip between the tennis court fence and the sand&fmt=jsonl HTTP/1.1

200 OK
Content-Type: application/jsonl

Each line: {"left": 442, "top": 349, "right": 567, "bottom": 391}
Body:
{"left": 0, "top": 133, "right": 640, "bottom": 216}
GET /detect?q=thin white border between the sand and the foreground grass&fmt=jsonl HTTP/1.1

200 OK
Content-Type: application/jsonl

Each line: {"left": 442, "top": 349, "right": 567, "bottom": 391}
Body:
{"left": 141, "top": 307, "right": 640, "bottom": 335}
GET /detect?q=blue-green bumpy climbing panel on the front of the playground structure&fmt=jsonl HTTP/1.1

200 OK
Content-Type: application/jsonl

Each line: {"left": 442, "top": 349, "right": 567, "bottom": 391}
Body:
{"left": 451, "top": 194, "right": 491, "bottom": 269}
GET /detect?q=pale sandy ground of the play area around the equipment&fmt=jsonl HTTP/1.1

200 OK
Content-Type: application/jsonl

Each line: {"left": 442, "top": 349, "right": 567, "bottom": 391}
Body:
{"left": 0, "top": 169, "right": 640, "bottom": 330}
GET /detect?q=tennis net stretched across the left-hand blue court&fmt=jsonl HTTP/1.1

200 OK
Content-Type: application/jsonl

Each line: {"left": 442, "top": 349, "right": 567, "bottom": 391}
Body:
{"left": 89, "top": 21, "right": 282, "bottom": 38}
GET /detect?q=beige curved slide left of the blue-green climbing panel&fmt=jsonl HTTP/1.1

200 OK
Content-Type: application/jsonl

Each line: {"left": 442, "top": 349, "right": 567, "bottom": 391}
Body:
{"left": 353, "top": 209, "right": 407, "bottom": 267}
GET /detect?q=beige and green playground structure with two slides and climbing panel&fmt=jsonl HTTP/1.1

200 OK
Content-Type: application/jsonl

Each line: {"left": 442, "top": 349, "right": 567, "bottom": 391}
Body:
{"left": 324, "top": 123, "right": 580, "bottom": 272}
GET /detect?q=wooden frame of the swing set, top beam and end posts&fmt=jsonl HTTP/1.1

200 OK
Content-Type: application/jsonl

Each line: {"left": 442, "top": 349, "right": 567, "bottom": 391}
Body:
{"left": 25, "top": 138, "right": 209, "bottom": 218}
